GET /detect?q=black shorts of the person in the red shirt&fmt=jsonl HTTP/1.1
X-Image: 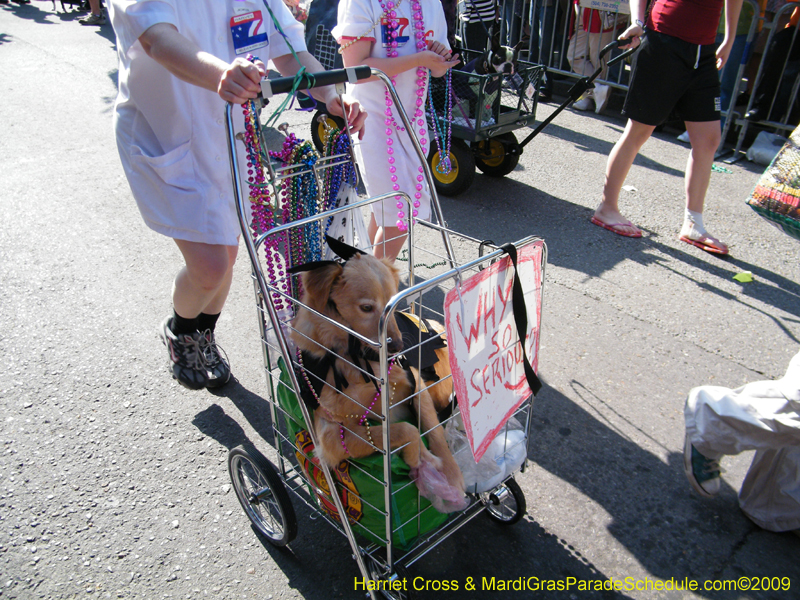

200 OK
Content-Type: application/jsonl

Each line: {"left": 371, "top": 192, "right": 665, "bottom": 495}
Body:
{"left": 622, "top": 30, "right": 720, "bottom": 126}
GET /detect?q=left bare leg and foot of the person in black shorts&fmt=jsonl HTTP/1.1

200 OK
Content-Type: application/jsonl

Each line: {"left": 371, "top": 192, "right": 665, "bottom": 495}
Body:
{"left": 594, "top": 119, "right": 655, "bottom": 237}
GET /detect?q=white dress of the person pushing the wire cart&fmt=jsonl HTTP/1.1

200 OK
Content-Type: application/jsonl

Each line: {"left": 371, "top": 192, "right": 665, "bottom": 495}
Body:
{"left": 109, "top": 0, "right": 306, "bottom": 246}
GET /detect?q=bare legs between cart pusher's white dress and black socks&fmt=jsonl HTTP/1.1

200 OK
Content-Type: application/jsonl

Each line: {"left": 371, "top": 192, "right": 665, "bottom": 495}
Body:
{"left": 172, "top": 240, "right": 239, "bottom": 319}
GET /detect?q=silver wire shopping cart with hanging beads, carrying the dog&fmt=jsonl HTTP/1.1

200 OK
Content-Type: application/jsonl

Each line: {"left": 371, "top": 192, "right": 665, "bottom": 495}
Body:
{"left": 226, "top": 67, "right": 547, "bottom": 599}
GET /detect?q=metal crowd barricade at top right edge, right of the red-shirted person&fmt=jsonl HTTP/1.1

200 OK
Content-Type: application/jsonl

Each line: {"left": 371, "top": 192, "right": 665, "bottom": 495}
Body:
{"left": 723, "top": 0, "right": 800, "bottom": 162}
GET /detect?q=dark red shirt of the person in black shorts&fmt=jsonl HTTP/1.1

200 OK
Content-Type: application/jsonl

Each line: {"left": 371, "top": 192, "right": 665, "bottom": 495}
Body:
{"left": 647, "top": 0, "right": 724, "bottom": 46}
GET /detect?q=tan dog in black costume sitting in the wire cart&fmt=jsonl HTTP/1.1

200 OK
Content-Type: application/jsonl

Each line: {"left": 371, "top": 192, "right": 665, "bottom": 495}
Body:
{"left": 292, "top": 238, "right": 464, "bottom": 503}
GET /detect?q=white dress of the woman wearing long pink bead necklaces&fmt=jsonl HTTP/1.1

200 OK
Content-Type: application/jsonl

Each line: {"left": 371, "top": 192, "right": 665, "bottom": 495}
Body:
{"left": 332, "top": 0, "right": 450, "bottom": 227}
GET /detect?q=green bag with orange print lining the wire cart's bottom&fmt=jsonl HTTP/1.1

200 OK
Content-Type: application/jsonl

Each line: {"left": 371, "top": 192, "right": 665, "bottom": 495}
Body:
{"left": 277, "top": 358, "right": 449, "bottom": 549}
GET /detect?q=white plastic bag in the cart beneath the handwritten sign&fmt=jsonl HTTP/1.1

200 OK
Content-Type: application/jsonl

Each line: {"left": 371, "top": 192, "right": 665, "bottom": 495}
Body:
{"left": 445, "top": 417, "right": 527, "bottom": 494}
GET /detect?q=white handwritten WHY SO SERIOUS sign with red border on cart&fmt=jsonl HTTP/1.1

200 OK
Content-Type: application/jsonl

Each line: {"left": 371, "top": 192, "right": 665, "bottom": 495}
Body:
{"left": 444, "top": 241, "right": 544, "bottom": 462}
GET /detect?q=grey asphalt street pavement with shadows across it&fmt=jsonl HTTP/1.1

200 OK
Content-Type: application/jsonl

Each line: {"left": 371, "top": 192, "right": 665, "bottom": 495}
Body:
{"left": 0, "top": 1, "right": 800, "bottom": 600}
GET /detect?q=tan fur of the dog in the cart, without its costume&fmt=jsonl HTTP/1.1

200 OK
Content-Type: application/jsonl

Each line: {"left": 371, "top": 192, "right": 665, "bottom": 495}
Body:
{"left": 292, "top": 254, "right": 464, "bottom": 491}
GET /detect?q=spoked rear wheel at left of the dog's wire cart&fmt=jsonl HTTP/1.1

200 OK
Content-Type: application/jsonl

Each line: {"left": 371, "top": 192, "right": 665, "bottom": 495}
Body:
{"left": 228, "top": 446, "right": 297, "bottom": 547}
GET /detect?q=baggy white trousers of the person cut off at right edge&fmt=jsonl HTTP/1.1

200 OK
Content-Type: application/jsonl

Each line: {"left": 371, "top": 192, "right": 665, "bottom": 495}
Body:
{"left": 684, "top": 353, "right": 800, "bottom": 531}
